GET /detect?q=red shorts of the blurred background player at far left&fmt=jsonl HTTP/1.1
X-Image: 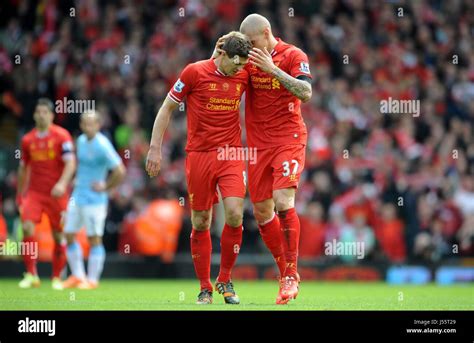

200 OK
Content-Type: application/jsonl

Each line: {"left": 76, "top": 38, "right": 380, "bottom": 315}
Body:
{"left": 21, "top": 192, "right": 69, "bottom": 232}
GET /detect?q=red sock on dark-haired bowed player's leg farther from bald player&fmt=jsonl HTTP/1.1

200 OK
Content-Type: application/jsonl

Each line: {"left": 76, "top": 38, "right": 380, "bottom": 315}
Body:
{"left": 191, "top": 228, "right": 213, "bottom": 292}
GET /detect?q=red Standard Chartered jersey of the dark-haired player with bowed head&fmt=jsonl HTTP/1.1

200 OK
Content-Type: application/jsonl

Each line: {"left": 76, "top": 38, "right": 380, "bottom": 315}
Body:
{"left": 168, "top": 59, "right": 248, "bottom": 151}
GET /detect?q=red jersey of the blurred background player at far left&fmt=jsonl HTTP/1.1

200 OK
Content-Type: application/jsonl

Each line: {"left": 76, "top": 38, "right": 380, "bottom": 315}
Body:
{"left": 21, "top": 124, "right": 73, "bottom": 195}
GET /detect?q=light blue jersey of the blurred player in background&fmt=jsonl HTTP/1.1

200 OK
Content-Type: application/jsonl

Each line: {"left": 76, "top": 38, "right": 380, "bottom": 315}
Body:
{"left": 72, "top": 132, "right": 122, "bottom": 206}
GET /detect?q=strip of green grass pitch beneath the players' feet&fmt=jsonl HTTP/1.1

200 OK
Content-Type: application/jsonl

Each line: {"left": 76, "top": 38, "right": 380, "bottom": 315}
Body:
{"left": 0, "top": 278, "right": 474, "bottom": 311}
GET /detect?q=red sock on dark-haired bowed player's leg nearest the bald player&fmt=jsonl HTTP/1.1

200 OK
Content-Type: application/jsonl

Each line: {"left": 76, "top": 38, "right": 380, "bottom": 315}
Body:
{"left": 217, "top": 224, "right": 242, "bottom": 282}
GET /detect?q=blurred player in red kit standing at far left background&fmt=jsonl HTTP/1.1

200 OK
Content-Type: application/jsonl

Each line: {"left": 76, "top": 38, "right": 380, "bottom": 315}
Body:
{"left": 17, "top": 98, "right": 75, "bottom": 290}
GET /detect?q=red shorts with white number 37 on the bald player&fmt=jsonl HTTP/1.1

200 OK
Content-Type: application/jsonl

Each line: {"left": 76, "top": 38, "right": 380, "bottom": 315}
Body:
{"left": 248, "top": 144, "right": 306, "bottom": 203}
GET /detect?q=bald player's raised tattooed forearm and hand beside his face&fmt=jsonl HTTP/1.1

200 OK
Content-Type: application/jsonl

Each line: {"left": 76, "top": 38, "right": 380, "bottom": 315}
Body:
{"left": 246, "top": 48, "right": 312, "bottom": 102}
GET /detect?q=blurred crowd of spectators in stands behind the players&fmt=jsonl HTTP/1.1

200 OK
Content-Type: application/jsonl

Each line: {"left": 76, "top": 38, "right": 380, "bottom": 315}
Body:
{"left": 0, "top": 0, "right": 474, "bottom": 263}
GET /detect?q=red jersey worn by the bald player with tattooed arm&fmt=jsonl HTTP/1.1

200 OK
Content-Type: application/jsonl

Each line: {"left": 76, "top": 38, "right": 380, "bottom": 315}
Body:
{"left": 245, "top": 38, "right": 311, "bottom": 149}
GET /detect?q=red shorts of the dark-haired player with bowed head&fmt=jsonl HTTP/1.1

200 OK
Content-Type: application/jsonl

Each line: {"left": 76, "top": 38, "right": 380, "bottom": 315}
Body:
{"left": 186, "top": 150, "right": 246, "bottom": 211}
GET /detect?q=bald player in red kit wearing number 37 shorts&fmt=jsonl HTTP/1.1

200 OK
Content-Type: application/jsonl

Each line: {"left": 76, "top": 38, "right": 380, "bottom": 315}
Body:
{"left": 240, "top": 14, "right": 312, "bottom": 304}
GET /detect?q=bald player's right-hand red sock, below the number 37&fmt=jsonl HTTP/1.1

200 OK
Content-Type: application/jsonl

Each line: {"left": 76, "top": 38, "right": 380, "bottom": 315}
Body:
{"left": 278, "top": 208, "right": 300, "bottom": 278}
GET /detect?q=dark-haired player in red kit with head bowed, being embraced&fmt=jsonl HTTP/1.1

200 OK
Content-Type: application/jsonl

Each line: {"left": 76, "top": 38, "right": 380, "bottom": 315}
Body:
{"left": 146, "top": 32, "right": 251, "bottom": 304}
